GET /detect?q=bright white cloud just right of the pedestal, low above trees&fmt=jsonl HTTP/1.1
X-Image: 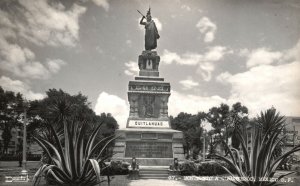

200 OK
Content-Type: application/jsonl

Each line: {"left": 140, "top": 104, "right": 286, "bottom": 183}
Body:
{"left": 168, "top": 90, "right": 227, "bottom": 116}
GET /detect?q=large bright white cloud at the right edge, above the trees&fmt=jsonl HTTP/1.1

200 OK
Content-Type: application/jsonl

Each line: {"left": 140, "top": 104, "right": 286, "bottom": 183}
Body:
{"left": 218, "top": 62, "right": 300, "bottom": 116}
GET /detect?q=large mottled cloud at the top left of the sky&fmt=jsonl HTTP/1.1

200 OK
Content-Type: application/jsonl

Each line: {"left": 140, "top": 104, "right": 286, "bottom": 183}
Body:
{"left": 14, "top": 0, "right": 86, "bottom": 46}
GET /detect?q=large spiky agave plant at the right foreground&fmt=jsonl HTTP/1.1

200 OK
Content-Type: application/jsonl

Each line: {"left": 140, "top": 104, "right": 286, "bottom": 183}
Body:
{"left": 215, "top": 109, "right": 300, "bottom": 186}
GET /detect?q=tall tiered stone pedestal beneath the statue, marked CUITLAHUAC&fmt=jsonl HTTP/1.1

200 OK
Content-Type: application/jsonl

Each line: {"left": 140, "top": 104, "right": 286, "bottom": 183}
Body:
{"left": 113, "top": 51, "right": 184, "bottom": 166}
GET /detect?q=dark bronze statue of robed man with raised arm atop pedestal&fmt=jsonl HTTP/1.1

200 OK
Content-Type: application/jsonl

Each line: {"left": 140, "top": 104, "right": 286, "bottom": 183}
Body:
{"left": 140, "top": 8, "right": 159, "bottom": 50}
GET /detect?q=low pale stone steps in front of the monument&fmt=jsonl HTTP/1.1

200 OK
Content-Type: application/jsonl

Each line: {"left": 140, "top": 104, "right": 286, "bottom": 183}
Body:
{"left": 139, "top": 166, "right": 169, "bottom": 179}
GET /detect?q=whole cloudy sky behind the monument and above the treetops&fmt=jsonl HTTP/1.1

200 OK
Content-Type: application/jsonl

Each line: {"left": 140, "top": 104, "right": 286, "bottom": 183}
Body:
{"left": 0, "top": 0, "right": 300, "bottom": 127}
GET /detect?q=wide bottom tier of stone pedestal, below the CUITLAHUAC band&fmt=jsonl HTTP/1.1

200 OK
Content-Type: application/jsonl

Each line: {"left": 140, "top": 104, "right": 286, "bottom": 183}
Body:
{"left": 113, "top": 128, "right": 184, "bottom": 166}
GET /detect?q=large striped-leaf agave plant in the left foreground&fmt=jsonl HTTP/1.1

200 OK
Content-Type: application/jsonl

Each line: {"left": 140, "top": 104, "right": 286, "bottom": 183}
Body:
{"left": 33, "top": 120, "right": 115, "bottom": 186}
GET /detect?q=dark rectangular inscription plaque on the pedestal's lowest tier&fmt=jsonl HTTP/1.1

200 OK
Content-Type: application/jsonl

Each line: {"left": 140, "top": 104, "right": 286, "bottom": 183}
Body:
{"left": 125, "top": 141, "right": 173, "bottom": 158}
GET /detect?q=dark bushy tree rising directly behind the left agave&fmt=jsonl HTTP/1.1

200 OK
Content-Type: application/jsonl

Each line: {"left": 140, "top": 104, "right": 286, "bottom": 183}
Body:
{"left": 28, "top": 89, "right": 101, "bottom": 133}
